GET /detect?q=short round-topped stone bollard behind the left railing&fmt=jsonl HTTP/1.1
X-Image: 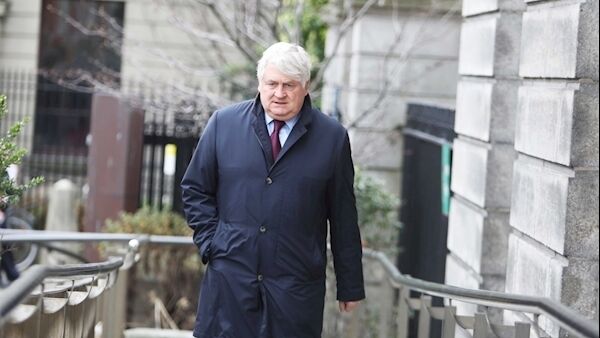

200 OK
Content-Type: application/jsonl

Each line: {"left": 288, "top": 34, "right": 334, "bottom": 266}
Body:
{"left": 41, "top": 179, "right": 82, "bottom": 264}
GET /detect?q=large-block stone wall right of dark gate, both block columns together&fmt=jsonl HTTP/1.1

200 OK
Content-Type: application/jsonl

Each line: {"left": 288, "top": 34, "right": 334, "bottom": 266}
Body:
{"left": 446, "top": 0, "right": 599, "bottom": 330}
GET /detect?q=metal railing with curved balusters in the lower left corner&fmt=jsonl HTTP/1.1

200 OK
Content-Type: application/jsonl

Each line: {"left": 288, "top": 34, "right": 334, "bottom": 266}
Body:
{"left": 0, "top": 230, "right": 145, "bottom": 338}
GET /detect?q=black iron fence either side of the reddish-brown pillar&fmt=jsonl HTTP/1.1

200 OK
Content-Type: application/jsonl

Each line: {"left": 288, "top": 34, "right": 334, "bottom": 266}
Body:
{"left": 0, "top": 70, "right": 210, "bottom": 222}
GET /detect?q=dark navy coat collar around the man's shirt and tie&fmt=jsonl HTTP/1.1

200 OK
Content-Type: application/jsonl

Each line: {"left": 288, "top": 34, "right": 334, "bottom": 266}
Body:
{"left": 252, "top": 94, "right": 313, "bottom": 172}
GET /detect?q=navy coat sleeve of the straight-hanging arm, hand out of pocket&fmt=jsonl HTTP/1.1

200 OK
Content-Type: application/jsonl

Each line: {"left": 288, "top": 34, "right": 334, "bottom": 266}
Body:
{"left": 327, "top": 133, "right": 365, "bottom": 301}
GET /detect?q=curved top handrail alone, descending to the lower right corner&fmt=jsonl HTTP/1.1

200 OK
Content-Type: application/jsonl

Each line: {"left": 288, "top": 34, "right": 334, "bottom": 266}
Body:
{"left": 363, "top": 248, "right": 599, "bottom": 338}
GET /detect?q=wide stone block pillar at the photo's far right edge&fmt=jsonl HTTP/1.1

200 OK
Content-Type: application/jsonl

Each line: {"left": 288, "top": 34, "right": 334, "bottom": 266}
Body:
{"left": 506, "top": 0, "right": 598, "bottom": 336}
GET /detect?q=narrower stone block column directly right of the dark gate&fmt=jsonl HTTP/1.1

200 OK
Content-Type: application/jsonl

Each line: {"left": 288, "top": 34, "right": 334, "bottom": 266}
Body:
{"left": 446, "top": 0, "right": 525, "bottom": 313}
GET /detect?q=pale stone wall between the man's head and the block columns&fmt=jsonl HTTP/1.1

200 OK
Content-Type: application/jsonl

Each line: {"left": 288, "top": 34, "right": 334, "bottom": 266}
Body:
{"left": 322, "top": 1, "right": 460, "bottom": 195}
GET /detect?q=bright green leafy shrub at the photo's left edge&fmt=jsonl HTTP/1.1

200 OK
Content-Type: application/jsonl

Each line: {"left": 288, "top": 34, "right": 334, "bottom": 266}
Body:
{"left": 0, "top": 95, "right": 44, "bottom": 207}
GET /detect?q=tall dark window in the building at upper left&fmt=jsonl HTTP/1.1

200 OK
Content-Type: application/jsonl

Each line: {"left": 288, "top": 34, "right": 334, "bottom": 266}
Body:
{"left": 34, "top": 0, "right": 124, "bottom": 154}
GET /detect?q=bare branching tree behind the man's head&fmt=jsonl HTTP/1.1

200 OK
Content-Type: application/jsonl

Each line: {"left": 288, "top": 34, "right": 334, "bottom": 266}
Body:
{"left": 41, "top": 0, "right": 458, "bottom": 129}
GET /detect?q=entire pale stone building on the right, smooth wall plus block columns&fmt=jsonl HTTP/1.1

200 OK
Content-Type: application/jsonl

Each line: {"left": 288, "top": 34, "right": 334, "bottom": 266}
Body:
{"left": 323, "top": 0, "right": 599, "bottom": 335}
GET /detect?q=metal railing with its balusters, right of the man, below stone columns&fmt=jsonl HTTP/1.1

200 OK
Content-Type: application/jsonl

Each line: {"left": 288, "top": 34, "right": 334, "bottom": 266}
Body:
{"left": 364, "top": 249, "right": 598, "bottom": 338}
